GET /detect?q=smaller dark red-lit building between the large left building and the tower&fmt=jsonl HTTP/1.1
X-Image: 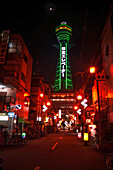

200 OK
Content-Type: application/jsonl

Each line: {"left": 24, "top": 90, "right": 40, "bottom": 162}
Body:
{"left": 29, "top": 75, "right": 50, "bottom": 122}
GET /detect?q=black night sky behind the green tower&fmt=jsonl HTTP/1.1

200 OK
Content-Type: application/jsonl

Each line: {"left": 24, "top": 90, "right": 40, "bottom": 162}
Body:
{"left": 0, "top": 0, "right": 112, "bottom": 89}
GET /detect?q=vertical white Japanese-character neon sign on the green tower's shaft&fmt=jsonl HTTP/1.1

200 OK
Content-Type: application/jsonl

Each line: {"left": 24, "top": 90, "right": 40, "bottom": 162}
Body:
{"left": 61, "top": 47, "right": 66, "bottom": 77}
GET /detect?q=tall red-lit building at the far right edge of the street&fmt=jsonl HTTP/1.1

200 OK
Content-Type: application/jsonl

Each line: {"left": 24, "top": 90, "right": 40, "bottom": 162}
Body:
{"left": 101, "top": 9, "right": 113, "bottom": 124}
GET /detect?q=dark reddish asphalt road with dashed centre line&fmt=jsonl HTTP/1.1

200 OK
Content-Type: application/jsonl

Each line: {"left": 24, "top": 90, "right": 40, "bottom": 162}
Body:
{"left": 0, "top": 131, "right": 106, "bottom": 170}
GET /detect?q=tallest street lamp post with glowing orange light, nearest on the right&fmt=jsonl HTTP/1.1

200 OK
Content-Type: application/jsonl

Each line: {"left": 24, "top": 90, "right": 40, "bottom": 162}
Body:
{"left": 90, "top": 67, "right": 102, "bottom": 148}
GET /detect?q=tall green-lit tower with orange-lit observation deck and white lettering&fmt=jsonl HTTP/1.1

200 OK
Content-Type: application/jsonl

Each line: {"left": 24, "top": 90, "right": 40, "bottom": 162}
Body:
{"left": 54, "top": 22, "right": 73, "bottom": 91}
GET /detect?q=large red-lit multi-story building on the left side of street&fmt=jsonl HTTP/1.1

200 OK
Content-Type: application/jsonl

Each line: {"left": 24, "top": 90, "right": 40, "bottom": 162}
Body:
{"left": 0, "top": 31, "right": 33, "bottom": 119}
